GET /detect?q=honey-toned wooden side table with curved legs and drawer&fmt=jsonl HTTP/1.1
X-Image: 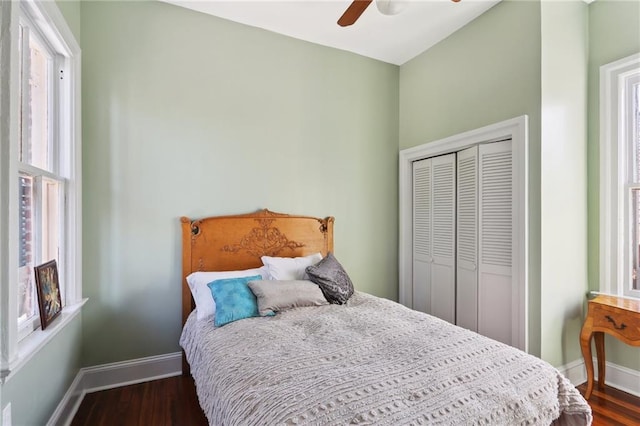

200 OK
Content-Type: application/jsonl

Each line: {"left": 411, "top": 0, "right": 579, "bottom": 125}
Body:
{"left": 580, "top": 295, "right": 640, "bottom": 399}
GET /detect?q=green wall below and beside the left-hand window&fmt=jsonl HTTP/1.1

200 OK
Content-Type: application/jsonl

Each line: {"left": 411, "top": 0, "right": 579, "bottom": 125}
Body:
{"left": 0, "top": 1, "right": 82, "bottom": 426}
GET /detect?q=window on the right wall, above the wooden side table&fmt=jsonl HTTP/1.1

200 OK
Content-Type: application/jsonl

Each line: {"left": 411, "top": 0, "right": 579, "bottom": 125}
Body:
{"left": 600, "top": 54, "right": 640, "bottom": 297}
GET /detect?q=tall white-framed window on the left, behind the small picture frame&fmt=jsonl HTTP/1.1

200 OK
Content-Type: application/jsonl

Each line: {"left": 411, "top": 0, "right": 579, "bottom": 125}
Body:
{"left": 0, "top": 0, "right": 82, "bottom": 379}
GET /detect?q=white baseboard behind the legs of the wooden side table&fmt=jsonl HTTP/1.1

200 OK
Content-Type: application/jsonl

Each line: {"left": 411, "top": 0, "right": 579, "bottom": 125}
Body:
{"left": 558, "top": 357, "right": 640, "bottom": 396}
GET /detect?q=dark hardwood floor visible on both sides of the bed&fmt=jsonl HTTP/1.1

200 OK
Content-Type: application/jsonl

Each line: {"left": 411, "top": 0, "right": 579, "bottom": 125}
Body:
{"left": 71, "top": 376, "right": 640, "bottom": 426}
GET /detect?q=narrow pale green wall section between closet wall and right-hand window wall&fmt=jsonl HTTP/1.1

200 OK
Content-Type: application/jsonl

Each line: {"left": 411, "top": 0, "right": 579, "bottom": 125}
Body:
{"left": 540, "top": 1, "right": 588, "bottom": 366}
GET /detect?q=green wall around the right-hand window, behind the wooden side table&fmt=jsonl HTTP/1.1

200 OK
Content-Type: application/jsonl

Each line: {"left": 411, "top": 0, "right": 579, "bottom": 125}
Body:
{"left": 588, "top": 0, "right": 640, "bottom": 370}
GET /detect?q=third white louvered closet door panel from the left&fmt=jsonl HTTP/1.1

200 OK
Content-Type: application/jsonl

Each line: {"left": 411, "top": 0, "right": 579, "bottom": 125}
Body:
{"left": 456, "top": 146, "right": 478, "bottom": 331}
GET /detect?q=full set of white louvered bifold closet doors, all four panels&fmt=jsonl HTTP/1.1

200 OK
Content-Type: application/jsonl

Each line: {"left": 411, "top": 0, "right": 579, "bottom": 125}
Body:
{"left": 411, "top": 140, "right": 518, "bottom": 345}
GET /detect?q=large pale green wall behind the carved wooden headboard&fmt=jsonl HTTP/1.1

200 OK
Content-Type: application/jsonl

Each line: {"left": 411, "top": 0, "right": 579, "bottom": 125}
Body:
{"left": 81, "top": 2, "right": 399, "bottom": 366}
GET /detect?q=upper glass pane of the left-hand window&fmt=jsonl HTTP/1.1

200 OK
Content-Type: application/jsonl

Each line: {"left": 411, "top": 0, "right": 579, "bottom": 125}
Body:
{"left": 20, "top": 29, "right": 52, "bottom": 171}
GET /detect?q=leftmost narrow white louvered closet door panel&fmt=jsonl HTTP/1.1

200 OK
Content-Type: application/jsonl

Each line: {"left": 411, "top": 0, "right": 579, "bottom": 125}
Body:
{"left": 412, "top": 159, "right": 433, "bottom": 313}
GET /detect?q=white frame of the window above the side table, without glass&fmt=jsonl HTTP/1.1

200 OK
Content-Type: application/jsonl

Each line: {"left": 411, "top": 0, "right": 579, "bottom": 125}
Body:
{"left": 599, "top": 53, "right": 640, "bottom": 298}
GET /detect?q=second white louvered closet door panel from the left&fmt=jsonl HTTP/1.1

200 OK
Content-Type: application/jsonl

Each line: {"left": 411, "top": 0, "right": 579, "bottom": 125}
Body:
{"left": 430, "top": 154, "right": 456, "bottom": 324}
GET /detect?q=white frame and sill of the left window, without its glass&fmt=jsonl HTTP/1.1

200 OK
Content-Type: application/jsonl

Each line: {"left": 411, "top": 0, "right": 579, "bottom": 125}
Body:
{"left": 0, "top": 0, "right": 86, "bottom": 383}
